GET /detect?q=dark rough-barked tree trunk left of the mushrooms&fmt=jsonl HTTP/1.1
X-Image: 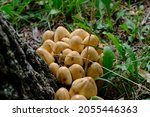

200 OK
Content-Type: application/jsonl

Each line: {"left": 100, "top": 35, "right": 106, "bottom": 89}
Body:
{"left": 0, "top": 15, "right": 57, "bottom": 99}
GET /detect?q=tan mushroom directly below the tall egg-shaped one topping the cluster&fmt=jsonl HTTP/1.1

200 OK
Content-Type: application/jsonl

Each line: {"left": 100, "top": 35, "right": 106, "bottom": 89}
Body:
{"left": 54, "top": 41, "right": 69, "bottom": 54}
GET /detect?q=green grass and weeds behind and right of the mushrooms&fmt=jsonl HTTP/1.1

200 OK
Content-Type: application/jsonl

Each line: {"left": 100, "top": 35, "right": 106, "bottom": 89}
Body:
{"left": 0, "top": 0, "right": 150, "bottom": 99}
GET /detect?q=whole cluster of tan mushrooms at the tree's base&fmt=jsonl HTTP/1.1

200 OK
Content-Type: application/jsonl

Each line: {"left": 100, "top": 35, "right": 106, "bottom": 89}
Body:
{"left": 36, "top": 26, "right": 103, "bottom": 100}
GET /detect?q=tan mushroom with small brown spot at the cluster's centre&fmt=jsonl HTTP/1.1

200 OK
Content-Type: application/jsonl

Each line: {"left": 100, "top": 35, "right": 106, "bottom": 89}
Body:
{"left": 64, "top": 51, "right": 83, "bottom": 66}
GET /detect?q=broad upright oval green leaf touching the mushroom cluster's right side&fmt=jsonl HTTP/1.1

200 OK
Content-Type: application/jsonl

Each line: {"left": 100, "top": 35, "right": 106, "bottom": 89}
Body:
{"left": 103, "top": 46, "right": 115, "bottom": 72}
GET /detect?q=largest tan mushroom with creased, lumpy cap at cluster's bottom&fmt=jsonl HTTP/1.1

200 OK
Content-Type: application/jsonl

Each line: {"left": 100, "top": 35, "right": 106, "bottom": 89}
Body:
{"left": 69, "top": 77, "right": 97, "bottom": 99}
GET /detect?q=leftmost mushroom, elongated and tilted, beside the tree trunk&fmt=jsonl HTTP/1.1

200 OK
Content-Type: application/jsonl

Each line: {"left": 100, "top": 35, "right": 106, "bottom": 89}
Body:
{"left": 36, "top": 47, "right": 55, "bottom": 65}
